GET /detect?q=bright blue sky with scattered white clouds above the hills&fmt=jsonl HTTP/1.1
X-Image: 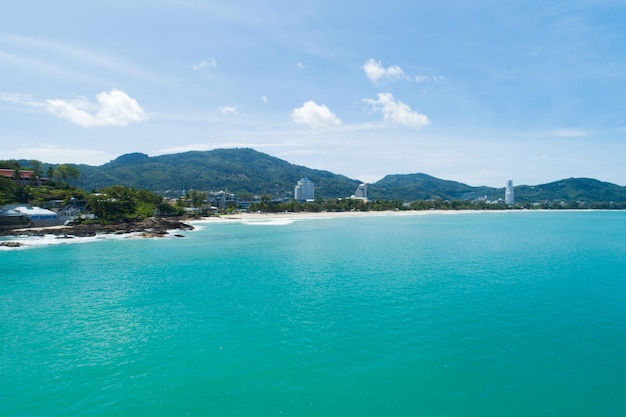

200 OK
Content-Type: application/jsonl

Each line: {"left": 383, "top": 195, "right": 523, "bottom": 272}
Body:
{"left": 0, "top": 0, "right": 626, "bottom": 187}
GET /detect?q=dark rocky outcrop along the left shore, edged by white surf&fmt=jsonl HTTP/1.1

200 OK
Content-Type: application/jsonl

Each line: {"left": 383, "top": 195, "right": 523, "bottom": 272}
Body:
{"left": 2, "top": 217, "right": 193, "bottom": 239}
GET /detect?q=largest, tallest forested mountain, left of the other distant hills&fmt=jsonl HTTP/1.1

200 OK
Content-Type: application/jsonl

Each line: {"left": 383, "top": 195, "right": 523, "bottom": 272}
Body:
{"left": 78, "top": 148, "right": 359, "bottom": 198}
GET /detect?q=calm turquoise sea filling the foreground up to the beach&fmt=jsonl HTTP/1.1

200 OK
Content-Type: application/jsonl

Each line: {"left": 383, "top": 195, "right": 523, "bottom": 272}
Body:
{"left": 0, "top": 211, "right": 626, "bottom": 417}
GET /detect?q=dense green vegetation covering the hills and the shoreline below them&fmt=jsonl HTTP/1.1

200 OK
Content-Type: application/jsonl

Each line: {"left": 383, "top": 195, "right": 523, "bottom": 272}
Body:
{"left": 0, "top": 149, "right": 626, "bottom": 214}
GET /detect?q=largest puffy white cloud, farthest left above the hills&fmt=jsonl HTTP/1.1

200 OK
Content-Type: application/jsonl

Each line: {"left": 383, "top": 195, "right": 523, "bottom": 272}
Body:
{"left": 46, "top": 89, "right": 146, "bottom": 127}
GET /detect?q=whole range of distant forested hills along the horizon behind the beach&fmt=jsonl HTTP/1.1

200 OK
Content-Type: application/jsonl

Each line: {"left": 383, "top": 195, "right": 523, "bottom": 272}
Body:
{"left": 77, "top": 148, "right": 626, "bottom": 202}
